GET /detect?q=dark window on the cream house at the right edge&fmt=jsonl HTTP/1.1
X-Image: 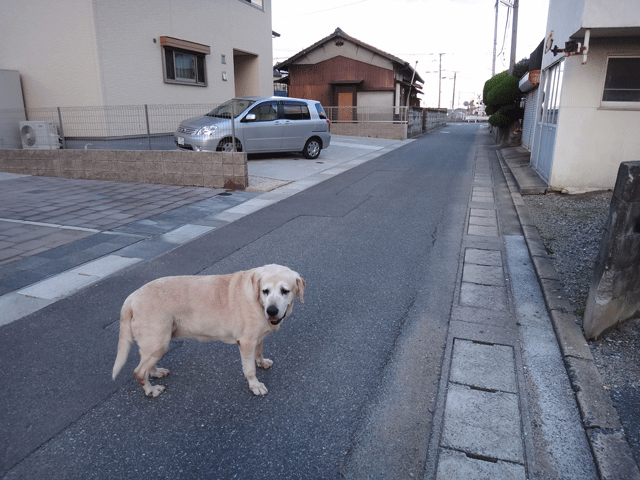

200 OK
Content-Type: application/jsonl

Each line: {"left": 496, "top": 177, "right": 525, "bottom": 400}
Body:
{"left": 602, "top": 57, "right": 640, "bottom": 108}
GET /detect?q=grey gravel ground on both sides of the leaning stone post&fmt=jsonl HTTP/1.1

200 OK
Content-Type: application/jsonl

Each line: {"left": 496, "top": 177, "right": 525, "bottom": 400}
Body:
{"left": 522, "top": 191, "right": 640, "bottom": 464}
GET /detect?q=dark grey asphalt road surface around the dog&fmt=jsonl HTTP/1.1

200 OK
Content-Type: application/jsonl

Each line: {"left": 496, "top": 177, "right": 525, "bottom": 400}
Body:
{"left": 0, "top": 125, "right": 478, "bottom": 479}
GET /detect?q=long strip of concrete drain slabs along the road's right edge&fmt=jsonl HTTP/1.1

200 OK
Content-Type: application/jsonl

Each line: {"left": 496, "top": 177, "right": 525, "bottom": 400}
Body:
{"left": 425, "top": 138, "right": 597, "bottom": 480}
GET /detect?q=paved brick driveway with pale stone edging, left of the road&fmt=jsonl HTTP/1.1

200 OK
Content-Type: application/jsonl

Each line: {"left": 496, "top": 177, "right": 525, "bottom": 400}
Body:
{"left": 0, "top": 137, "right": 411, "bottom": 325}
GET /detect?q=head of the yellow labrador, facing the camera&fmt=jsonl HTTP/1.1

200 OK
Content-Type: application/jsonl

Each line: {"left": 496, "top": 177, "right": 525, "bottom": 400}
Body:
{"left": 252, "top": 265, "right": 306, "bottom": 326}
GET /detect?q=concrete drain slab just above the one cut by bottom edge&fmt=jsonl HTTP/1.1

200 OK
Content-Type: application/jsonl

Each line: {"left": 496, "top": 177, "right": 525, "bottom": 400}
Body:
{"left": 441, "top": 383, "right": 524, "bottom": 463}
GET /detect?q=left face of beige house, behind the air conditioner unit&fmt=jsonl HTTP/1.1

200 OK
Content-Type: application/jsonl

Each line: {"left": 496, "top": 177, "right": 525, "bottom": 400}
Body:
{"left": 0, "top": 0, "right": 103, "bottom": 107}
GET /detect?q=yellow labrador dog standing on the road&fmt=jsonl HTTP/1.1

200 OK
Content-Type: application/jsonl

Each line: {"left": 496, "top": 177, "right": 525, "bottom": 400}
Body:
{"left": 113, "top": 265, "right": 306, "bottom": 397}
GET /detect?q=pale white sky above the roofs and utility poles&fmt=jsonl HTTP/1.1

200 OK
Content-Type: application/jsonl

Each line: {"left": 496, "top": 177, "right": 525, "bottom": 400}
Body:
{"left": 271, "top": 0, "right": 549, "bottom": 108}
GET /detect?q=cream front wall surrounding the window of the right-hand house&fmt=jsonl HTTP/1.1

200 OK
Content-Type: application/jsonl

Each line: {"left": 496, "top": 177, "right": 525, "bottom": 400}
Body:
{"left": 549, "top": 38, "right": 640, "bottom": 188}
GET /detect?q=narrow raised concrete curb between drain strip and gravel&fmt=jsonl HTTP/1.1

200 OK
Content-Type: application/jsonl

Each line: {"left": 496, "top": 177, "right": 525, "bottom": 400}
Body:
{"left": 496, "top": 148, "right": 640, "bottom": 480}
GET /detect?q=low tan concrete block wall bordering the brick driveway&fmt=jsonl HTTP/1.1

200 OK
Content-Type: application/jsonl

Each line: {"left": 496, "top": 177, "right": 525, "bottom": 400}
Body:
{"left": 0, "top": 149, "right": 249, "bottom": 190}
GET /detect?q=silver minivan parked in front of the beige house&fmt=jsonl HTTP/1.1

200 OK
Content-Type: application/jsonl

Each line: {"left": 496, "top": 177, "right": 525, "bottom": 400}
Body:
{"left": 174, "top": 97, "right": 331, "bottom": 159}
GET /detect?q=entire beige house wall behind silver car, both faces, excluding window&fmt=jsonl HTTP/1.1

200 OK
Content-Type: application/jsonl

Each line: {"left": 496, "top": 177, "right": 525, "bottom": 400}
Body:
{"left": 0, "top": 0, "right": 273, "bottom": 108}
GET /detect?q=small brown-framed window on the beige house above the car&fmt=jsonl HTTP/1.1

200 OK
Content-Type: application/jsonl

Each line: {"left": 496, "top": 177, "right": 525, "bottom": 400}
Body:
{"left": 160, "top": 37, "right": 211, "bottom": 86}
